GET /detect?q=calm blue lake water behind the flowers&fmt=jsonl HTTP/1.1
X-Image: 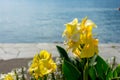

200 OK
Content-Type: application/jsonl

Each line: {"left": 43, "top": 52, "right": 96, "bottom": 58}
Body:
{"left": 0, "top": 0, "right": 120, "bottom": 43}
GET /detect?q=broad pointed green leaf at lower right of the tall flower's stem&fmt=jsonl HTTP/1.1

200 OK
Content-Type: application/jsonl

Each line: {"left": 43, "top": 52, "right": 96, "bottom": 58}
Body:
{"left": 95, "top": 55, "right": 109, "bottom": 80}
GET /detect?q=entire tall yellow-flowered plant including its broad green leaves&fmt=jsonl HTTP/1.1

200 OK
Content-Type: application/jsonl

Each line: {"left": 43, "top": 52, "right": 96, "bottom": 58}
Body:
{"left": 57, "top": 17, "right": 120, "bottom": 80}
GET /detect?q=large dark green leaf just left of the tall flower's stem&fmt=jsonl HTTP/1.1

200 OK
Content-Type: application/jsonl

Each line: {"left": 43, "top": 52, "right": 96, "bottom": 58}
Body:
{"left": 62, "top": 59, "right": 81, "bottom": 80}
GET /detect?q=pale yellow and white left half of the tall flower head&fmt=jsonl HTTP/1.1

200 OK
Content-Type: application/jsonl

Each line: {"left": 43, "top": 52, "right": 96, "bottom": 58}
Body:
{"left": 63, "top": 18, "right": 80, "bottom": 49}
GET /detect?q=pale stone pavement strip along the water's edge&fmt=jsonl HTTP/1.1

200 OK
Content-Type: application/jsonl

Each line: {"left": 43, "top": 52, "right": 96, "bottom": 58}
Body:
{"left": 0, "top": 43, "right": 120, "bottom": 63}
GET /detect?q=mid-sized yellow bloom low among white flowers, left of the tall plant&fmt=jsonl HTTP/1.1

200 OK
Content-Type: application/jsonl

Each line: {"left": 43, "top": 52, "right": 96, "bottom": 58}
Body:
{"left": 29, "top": 50, "right": 56, "bottom": 79}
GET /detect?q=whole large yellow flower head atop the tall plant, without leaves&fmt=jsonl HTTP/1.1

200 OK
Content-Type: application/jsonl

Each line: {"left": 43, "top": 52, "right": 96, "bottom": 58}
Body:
{"left": 63, "top": 17, "right": 98, "bottom": 58}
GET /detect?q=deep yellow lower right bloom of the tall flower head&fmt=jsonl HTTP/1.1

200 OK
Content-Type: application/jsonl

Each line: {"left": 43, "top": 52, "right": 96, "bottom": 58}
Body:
{"left": 77, "top": 37, "right": 98, "bottom": 58}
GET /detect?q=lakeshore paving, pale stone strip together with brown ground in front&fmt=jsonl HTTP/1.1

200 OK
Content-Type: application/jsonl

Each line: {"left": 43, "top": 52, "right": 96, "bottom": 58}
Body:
{"left": 0, "top": 43, "right": 120, "bottom": 73}
